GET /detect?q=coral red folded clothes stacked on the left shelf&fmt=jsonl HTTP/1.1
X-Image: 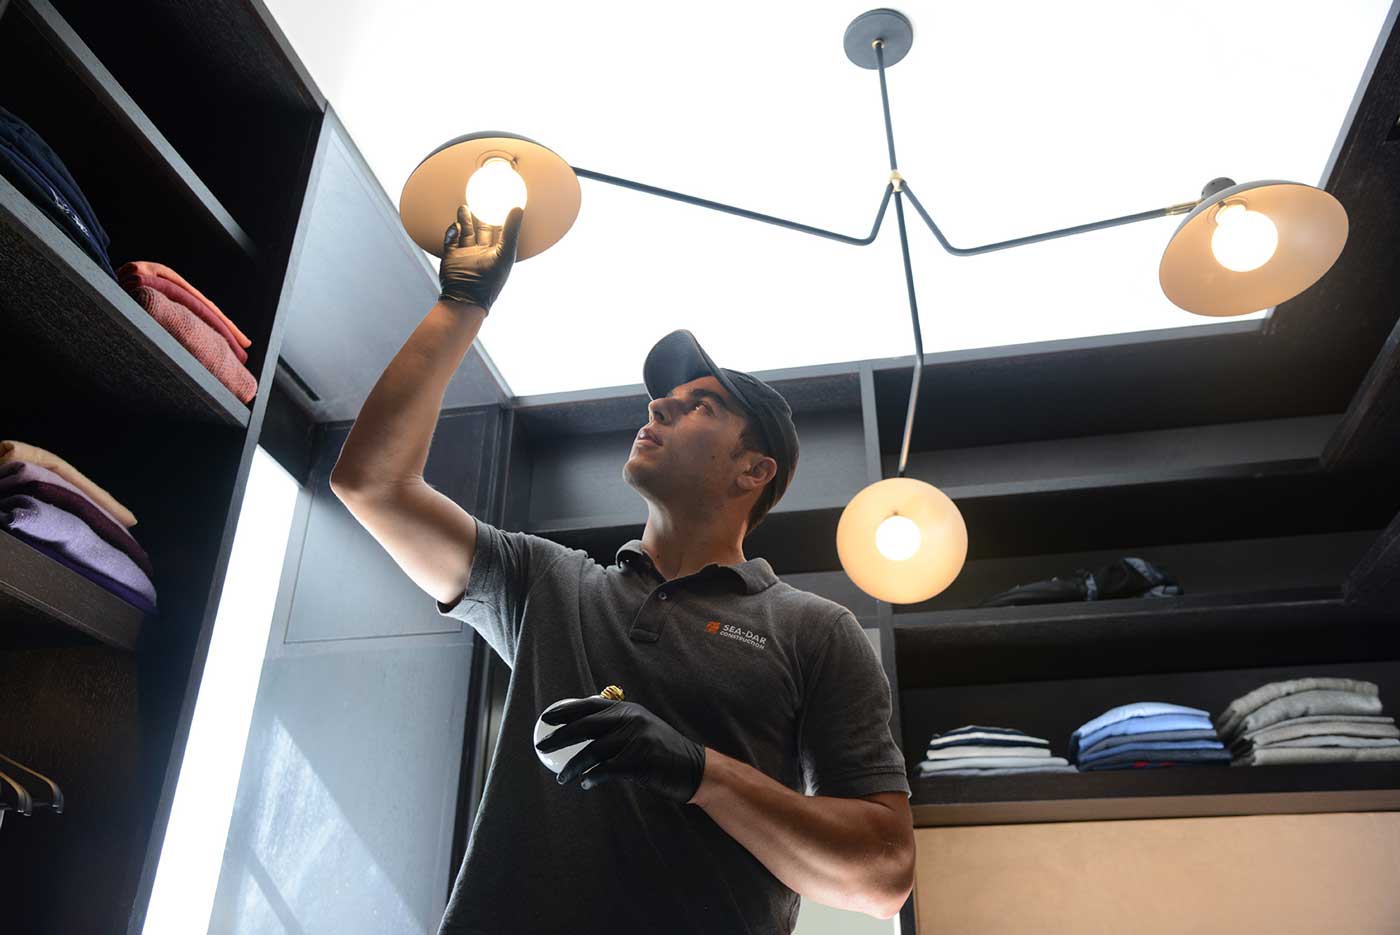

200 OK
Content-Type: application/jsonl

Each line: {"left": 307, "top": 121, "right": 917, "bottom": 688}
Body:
{"left": 116, "top": 260, "right": 258, "bottom": 403}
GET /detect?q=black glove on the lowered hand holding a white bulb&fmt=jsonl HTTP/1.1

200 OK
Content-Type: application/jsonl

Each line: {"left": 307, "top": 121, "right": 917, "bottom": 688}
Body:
{"left": 535, "top": 698, "right": 704, "bottom": 805}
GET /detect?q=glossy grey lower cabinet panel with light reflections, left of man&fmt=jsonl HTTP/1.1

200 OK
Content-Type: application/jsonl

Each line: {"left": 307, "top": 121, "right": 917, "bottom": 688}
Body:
{"left": 209, "top": 642, "right": 472, "bottom": 935}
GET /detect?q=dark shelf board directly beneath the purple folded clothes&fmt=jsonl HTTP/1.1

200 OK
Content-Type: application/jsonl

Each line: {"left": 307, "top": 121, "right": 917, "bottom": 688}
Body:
{"left": 0, "top": 532, "right": 146, "bottom": 649}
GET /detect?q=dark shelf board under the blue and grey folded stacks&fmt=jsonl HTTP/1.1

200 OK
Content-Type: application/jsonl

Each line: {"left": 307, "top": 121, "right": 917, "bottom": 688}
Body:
{"left": 910, "top": 763, "right": 1400, "bottom": 827}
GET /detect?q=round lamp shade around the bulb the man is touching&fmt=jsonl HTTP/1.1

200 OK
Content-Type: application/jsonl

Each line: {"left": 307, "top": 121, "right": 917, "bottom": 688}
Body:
{"left": 399, "top": 130, "right": 580, "bottom": 260}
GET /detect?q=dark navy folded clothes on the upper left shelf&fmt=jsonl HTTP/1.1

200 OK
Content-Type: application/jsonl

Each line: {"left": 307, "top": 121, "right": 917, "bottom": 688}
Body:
{"left": 0, "top": 108, "right": 116, "bottom": 279}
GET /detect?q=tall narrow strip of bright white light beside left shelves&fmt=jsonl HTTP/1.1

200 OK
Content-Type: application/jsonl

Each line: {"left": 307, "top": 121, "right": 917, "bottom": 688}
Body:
{"left": 141, "top": 448, "right": 298, "bottom": 935}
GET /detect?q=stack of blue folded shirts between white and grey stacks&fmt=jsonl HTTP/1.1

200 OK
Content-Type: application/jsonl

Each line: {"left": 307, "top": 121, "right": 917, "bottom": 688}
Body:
{"left": 1070, "top": 701, "right": 1231, "bottom": 773}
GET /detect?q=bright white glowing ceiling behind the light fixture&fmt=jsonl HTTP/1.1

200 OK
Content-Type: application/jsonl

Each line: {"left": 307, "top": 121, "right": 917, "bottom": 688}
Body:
{"left": 266, "top": 0, "right": 1387, "bottom": 396}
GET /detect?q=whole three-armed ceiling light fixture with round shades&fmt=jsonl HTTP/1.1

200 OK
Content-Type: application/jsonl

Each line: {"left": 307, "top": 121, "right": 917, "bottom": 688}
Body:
{"left": 399, "top": 8, "right": 1347, "bottom": 603}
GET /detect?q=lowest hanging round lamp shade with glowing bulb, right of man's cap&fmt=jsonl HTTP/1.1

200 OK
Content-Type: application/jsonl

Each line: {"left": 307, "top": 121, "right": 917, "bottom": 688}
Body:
{"left": 836, "top": 477, "right": 967, "bottom": 603}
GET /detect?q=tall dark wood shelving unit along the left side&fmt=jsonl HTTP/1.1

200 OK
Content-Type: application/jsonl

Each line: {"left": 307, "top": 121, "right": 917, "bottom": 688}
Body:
{"left": 0, "top": 0, "right": 326, "bottom": 935}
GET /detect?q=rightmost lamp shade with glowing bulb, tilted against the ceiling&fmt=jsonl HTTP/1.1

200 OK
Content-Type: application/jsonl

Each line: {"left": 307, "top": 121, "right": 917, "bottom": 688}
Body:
{"left": 1158, "top": 182, "right": 1347, "bottom": 316}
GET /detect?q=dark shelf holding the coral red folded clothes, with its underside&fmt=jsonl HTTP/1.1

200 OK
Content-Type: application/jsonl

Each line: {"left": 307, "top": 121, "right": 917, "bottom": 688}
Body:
{"left": 0, "top": 178, "right": 249, "bottom": 428}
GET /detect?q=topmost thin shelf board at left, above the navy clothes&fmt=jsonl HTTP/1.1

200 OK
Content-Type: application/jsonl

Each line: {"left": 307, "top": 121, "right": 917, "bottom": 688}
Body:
{"left": 14, "top": 0, "right": 258, "bottom": 259}
